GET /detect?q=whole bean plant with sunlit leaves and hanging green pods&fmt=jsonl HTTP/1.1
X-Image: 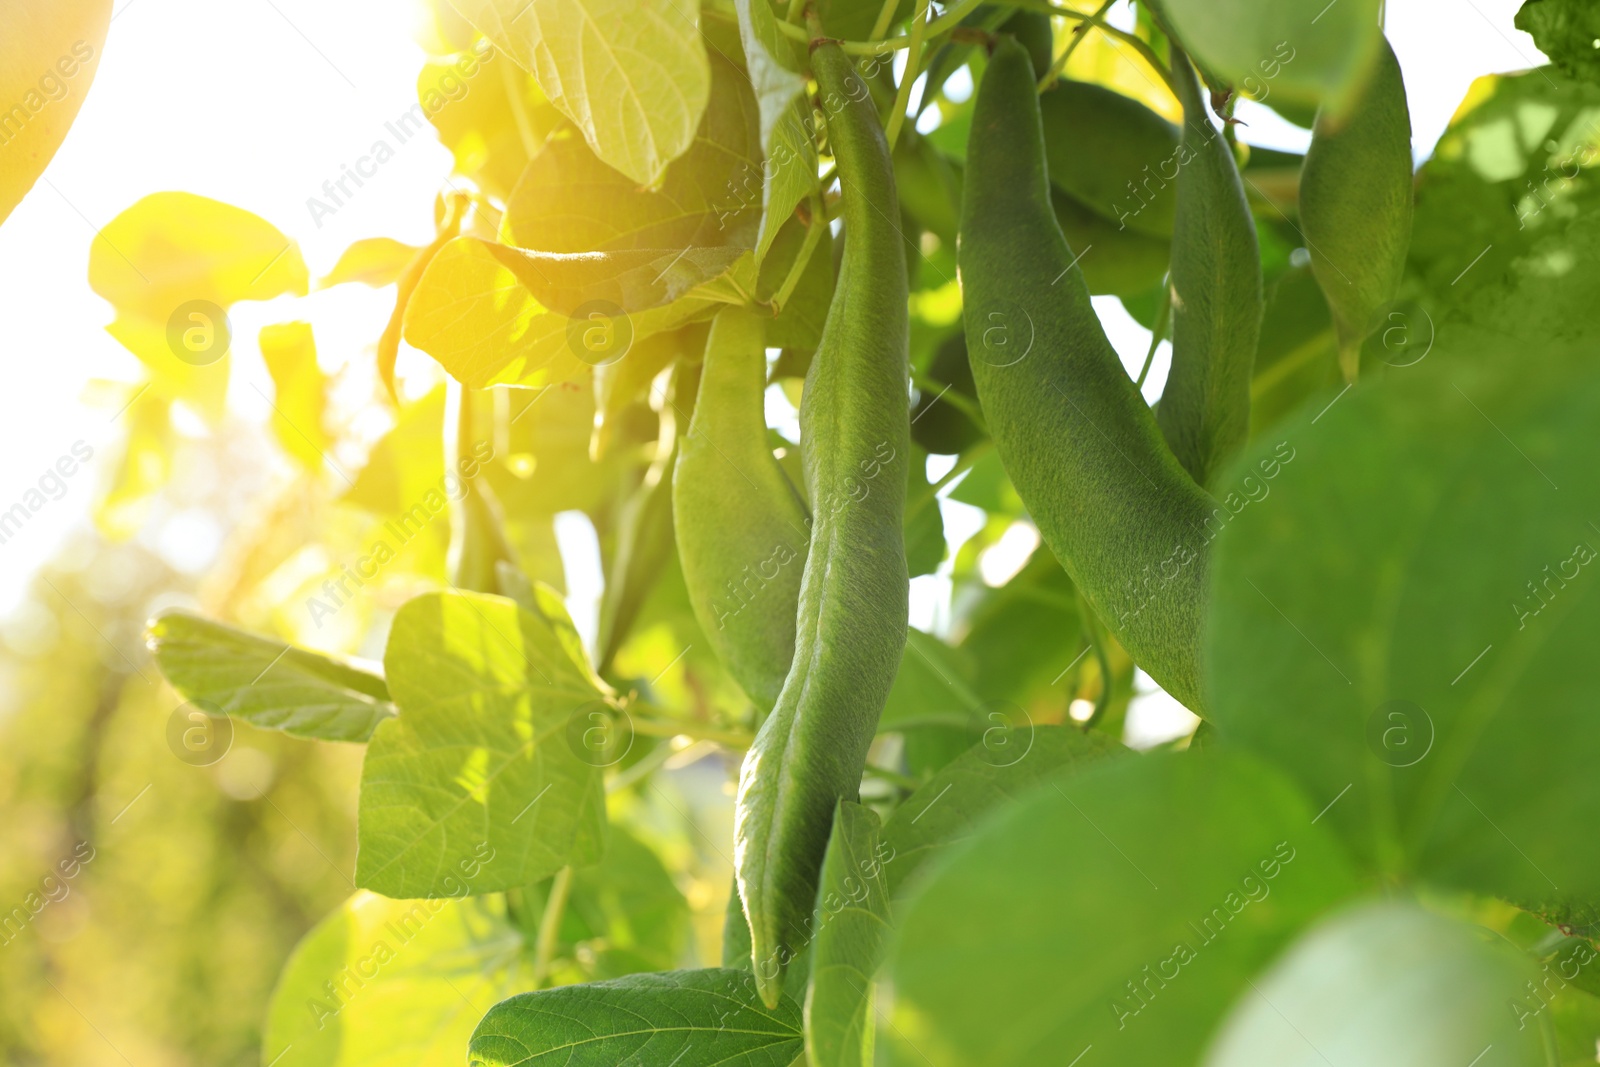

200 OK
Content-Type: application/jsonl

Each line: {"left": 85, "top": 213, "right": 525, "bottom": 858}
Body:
{"left": 18, "top": 0, "right": 1600, "bottom": 1067}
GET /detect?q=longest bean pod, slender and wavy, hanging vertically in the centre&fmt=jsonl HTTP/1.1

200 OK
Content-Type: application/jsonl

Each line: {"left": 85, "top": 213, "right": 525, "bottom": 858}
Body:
{"left": 734, "top": 40, "right": 908, "bottom": 1005}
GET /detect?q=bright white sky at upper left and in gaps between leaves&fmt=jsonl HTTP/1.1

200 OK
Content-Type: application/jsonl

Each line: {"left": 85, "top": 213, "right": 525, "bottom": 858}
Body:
{"left": 0, "top": 0, "right": 1542, "bottom": 684}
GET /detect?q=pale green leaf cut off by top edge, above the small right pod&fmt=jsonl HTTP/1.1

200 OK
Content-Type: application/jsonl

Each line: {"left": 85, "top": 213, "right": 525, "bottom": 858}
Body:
{"left": 1154, "top": 0, "right": 1381, "bottom": 116}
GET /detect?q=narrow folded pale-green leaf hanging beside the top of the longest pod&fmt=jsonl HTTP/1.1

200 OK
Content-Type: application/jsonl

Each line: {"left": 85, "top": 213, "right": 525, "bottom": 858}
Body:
{"left": 734, "top": 0, "right": 816, "bottom": 259}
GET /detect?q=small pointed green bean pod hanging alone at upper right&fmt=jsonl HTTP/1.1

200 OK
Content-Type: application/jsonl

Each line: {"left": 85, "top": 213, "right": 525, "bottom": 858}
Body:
{"left": 1299, "top": 40, "right": 1411, "bottom": 381}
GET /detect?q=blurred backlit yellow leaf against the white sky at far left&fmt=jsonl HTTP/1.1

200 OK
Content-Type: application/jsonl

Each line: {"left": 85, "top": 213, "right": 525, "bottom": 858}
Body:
{"left": 90, "top": 192, "right": 307, "bottom": 419}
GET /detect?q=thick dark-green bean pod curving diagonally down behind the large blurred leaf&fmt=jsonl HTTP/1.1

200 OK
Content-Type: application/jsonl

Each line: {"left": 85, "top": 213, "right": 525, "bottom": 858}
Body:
{"left": 958, "top": 40, "right": 1211, "bottom": 710}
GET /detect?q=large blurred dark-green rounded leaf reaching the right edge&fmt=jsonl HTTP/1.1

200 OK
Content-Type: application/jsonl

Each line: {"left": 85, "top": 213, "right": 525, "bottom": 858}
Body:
{"left": 1206, "top": 231, "right": 1600, "bottom": 915}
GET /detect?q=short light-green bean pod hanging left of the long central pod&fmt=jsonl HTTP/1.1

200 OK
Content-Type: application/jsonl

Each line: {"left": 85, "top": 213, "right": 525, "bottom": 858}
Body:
{"left": 672, "top": 307, "right": 811, "bottom": 712}
